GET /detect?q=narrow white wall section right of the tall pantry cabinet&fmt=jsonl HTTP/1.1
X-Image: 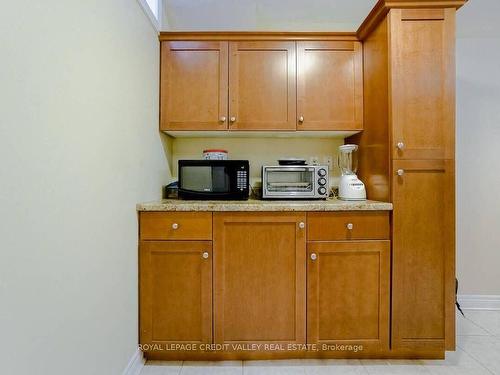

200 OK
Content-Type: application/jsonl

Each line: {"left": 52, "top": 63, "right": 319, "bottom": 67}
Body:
{"left": 457, "top": 0, "right": 500, "bottom": 295}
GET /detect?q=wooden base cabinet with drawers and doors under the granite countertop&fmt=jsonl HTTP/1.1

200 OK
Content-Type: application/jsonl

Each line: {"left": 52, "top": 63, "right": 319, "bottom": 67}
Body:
{"left": 139, "top": 209, "right": 392, "bottom": 359}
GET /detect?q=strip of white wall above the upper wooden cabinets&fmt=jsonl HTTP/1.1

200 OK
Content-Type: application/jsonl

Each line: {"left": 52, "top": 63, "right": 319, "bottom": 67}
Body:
{"left": 162, "top": 0, "right": 376, "bottom": 31}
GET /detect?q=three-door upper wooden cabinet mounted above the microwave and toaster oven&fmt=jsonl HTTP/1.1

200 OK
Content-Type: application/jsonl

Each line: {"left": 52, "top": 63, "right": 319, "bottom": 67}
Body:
{"left": 160, "top": 35, "right": 363, "bottom": 131}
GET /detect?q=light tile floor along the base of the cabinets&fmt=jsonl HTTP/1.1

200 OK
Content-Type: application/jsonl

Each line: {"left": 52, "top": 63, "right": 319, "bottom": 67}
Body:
{"left": 141, "top": 310, "right": 500, "bottom": 375}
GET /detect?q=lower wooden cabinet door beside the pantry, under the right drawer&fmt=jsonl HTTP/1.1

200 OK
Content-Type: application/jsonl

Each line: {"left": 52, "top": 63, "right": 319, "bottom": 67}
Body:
{"left": 307, "top": 241, "right": 390, "bottom": 350}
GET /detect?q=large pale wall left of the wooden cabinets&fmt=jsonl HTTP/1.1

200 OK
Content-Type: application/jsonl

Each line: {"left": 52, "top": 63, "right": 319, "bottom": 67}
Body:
{"left": 0, "top": 0, "right": 169, "bottom": 375}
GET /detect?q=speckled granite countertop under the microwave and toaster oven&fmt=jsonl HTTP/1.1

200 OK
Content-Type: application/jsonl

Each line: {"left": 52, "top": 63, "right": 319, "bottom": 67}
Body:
{"left": 137, "top": 198, "right": 392, "bottom": 211}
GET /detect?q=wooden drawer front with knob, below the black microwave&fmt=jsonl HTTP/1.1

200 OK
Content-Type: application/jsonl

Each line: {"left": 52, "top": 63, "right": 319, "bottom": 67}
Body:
{"left": 139, "top": 212, "right": 212, "bottom": 240}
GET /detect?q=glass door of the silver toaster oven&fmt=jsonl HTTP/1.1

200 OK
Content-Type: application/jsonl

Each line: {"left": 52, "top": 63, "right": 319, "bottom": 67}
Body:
{"left": 262, "top": 167, "right": 315, "bottom": 198}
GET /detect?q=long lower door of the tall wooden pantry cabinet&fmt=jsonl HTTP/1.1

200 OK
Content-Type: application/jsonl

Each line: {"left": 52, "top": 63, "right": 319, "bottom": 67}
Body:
{"left": 392, "top": 160, "right": 455, "bottom": 349}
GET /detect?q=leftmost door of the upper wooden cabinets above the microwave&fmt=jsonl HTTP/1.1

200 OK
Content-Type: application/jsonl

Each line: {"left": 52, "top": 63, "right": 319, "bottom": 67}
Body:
{"left": 160, "top": 41, "right": 228, "bottom": 130}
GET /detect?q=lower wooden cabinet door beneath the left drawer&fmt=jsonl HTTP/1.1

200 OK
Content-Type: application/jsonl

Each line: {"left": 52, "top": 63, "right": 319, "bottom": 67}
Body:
{"left": 139, "top": 241, "right": 212, "bottom": 344}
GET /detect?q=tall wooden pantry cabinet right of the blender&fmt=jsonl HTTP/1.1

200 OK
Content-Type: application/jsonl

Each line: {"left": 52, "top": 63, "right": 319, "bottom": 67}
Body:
{"left": 348, "top": 1, "right": 458, "bottom": 352}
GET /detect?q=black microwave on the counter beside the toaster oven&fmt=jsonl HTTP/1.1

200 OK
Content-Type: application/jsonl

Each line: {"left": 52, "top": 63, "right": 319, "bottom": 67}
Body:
{"left": 178, "top": 160, "right": 250, "bottom": 200}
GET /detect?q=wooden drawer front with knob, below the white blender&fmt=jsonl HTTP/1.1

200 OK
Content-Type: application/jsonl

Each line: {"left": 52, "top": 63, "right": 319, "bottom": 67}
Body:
{"left": 307, "top": 211, "right": 390, "bottom": 241}
